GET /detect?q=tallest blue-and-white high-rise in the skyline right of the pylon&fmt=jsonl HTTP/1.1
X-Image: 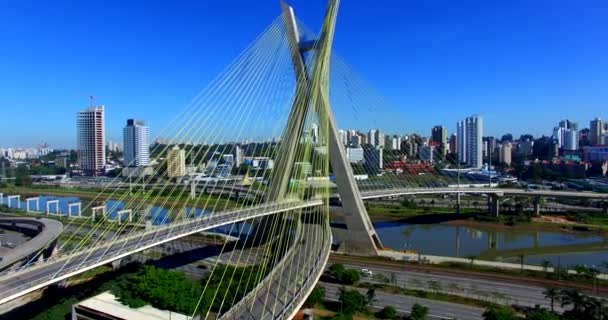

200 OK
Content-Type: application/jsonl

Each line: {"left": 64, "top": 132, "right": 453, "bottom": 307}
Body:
{"left": 456, "top": 116, "right": 483, "bottom": 168}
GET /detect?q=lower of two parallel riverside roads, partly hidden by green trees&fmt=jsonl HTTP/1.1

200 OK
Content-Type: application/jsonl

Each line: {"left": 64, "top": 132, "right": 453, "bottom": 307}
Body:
{"left": 319, "top": 282, "right": 484, "bottom": 320}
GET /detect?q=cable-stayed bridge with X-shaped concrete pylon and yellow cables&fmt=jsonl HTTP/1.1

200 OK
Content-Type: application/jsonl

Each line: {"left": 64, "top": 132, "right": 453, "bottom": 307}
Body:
{"left": 0, "top": 0, "right": 608, "bottom": 319}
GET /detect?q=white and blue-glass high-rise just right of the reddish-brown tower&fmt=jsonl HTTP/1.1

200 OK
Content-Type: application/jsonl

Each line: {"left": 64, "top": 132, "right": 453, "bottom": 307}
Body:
{"left": 122, "top": 119, "right": 150, "bottom": 167}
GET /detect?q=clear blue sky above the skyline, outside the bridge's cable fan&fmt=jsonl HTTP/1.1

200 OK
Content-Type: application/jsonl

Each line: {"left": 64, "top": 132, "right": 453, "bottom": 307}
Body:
{"left": 0, "top": 0, "right": 608, "bottom": 147}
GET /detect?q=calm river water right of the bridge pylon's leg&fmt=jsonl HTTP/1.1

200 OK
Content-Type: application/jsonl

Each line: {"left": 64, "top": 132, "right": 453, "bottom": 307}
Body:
{"left": 374, "top": 222, "right": 608, "bottom": 267}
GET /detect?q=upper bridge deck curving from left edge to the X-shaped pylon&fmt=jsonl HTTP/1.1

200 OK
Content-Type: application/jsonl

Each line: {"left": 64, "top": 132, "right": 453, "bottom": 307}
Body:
{"left": 0, "top": 200, "right": 322, "bottom": 304}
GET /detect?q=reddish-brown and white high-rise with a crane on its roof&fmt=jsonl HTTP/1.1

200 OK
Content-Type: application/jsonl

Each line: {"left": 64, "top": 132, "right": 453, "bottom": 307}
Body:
{"left": 76, "top": 105, "right": 106, "bottom": 176}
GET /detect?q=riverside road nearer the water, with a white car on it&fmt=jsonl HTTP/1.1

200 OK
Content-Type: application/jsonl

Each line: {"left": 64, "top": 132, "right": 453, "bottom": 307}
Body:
{"left": 330, "top": 261, "right": 562, "bottom": 311}
